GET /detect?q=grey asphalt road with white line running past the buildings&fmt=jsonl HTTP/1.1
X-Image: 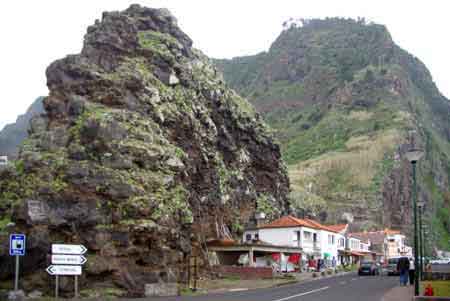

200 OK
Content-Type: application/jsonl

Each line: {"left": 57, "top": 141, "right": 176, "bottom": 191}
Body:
{"left": 146, "top": 275, "right": 398, "bottom": 301}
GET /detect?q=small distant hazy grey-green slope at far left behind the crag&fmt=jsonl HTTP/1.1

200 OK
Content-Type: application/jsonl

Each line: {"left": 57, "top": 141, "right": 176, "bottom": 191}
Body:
{"left": 0, "top": 97, "right": 44, "bottom": 160}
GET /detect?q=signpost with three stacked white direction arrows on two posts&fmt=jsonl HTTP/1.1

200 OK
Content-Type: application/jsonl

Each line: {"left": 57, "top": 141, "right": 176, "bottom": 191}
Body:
{"left": 47, "top": 244, "right": 87, "bottom": 298}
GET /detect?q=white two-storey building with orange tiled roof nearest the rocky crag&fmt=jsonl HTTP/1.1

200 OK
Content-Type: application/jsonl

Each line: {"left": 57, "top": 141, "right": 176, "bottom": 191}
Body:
{"left": 243, "top": 216, "right": 345, "bottom": 264}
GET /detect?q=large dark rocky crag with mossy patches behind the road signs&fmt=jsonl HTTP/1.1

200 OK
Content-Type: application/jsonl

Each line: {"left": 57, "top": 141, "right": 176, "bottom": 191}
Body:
{"left": 0, "top": 5, "right": 289, "bottom": 295}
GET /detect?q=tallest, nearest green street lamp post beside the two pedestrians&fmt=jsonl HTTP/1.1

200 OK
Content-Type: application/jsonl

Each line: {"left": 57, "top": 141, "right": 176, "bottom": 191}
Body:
{"left": 405, "top": 148, "right": 423, "bottom": 296}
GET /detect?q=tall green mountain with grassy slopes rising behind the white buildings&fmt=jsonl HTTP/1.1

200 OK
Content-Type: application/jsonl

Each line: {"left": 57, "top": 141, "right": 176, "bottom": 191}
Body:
{"left": 216, "top": 18, "right": 450, "bottom": 248}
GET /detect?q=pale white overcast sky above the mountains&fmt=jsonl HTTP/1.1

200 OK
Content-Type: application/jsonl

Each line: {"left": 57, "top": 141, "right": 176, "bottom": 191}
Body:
{"left": 0, "top": 0, "right": 450, "bottom": 129}
